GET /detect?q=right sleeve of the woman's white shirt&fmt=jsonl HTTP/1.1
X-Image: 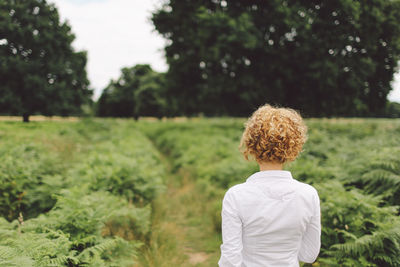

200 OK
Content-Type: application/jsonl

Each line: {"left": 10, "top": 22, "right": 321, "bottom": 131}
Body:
{"left": 298, "top": 191, "right": 321, "bottom": 263}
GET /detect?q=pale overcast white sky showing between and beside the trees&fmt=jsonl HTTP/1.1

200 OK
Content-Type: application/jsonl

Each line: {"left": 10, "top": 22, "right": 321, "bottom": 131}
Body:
{"left": 49, "top": 0, "right": 400, "bottom": 102}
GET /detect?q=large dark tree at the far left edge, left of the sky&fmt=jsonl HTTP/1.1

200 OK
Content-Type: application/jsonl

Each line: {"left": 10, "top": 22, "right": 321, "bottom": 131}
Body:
{"left": 0, "top": 0, "right": 92, "bottom": 122}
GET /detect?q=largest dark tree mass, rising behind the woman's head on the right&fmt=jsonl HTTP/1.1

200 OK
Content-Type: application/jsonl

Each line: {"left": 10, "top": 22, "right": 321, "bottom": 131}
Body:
{"left": 152, "top": 0, "right": 400, "bottom": 116}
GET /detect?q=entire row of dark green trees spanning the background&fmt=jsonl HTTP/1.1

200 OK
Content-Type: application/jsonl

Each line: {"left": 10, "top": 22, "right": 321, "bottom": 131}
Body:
{"left": 0, "top": 0, "right": 400, "bottom": 120}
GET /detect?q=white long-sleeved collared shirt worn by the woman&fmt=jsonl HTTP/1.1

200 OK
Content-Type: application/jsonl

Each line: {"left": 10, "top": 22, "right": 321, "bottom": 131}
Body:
{"left": 218, "top": 170, "right": 321, "bottom": 267}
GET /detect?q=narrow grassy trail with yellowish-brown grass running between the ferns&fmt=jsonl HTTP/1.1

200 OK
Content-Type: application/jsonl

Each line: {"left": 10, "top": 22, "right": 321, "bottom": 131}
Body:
{"left": 136, "top": 138, "right": 221, "bottom": 267}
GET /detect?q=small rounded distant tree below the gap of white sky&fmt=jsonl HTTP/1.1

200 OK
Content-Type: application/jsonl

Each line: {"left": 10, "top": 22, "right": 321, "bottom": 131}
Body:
{"left": 97, "top": 64, "right": 165, "bottom": 119}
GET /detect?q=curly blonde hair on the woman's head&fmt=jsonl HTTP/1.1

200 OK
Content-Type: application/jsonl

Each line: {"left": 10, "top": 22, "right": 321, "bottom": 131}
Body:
{"left": 240, "top": 104, "right": 307, "bottom": 163}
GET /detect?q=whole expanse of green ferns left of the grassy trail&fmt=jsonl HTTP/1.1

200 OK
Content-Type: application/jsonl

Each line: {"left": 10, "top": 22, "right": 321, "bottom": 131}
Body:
{"left": 0, "top": 120, "right": 164, "bottom": 266}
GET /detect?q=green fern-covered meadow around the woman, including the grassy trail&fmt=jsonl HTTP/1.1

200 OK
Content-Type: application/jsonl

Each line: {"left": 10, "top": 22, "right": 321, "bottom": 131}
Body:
{"left": 0, "top": 118, "right": 400, "bottom": 266}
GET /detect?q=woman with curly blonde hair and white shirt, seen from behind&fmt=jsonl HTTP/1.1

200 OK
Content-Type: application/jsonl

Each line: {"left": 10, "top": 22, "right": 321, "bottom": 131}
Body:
{"left": 219, "top": 105, "right": 321, "bottom": 267}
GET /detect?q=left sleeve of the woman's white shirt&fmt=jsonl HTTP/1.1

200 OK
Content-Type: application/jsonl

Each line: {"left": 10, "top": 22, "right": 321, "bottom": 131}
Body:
{"left": 218, "top": 190, "right": 243, "bottom": 267}
